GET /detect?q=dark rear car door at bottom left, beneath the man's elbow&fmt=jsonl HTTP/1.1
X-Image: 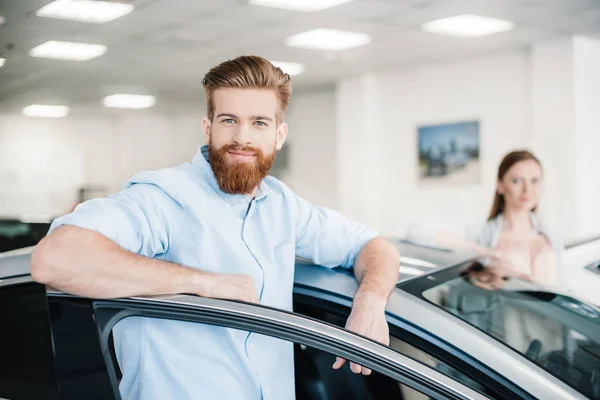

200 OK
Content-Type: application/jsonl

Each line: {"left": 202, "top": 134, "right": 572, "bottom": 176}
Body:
{"left": 0, "top": 276, "right": 113, "bottom": 400}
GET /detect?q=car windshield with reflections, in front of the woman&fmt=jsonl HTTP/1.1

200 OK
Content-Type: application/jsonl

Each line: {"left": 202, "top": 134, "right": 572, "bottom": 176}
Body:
{"left": 398, "top": 263, "right": 600, "bottom": 399}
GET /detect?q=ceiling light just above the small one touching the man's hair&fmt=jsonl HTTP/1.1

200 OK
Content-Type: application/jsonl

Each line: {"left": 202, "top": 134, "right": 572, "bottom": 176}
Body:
{"left": 285, "top": 29, "right": 371, "bottom": 51}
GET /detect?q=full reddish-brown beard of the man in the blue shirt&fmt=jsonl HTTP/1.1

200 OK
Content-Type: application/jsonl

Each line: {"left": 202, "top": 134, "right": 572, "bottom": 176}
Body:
{"left": 208, "top": 142, "right": 275, "bottom": 194}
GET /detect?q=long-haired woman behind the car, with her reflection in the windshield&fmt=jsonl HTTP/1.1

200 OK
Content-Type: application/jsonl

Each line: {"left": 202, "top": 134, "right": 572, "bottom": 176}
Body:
{"left": 407, "top": 151, "right": 565, "bottom": 353}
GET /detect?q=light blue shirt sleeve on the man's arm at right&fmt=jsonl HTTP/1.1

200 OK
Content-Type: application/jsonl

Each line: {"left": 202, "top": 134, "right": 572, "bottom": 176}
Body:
{"left": 296, "top": 197, "right": 377, "bottom": 268}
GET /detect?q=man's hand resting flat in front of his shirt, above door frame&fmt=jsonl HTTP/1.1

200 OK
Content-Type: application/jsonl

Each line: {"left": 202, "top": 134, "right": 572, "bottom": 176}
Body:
{"left": 196, "top": 273, "right": 260, "bottom": 304}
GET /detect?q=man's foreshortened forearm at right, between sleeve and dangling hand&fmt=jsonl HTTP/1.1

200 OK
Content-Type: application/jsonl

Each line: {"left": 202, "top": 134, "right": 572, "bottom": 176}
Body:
{"left": 354, "top": 237, "right": 400, "bottom": 307}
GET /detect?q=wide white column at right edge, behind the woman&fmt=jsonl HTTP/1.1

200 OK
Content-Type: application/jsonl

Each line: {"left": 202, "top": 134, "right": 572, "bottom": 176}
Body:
{"left": 531, "top": 37, "right": 600, "bottom": 240}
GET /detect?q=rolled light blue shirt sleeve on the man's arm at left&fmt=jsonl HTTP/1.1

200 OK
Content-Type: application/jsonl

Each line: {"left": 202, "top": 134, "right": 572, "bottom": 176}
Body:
{"left": 50, "top": 183, "right": 181, "bottom": 257}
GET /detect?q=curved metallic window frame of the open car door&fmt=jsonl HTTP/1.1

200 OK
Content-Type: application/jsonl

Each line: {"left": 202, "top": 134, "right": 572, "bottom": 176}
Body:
{"left": 93, "top": 295, "right": 486, "bottom": 399}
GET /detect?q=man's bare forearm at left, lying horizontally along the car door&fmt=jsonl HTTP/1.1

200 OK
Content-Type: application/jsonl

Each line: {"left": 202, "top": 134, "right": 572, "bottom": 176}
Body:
{"left": 31, "top": 226, "right": 203, "bottom": 298}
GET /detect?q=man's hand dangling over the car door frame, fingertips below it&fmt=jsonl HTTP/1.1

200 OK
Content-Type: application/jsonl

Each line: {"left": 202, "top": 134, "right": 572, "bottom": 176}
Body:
{"left": 333, "top": 294, "right": 390, "bottom": 375}
